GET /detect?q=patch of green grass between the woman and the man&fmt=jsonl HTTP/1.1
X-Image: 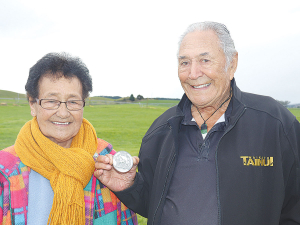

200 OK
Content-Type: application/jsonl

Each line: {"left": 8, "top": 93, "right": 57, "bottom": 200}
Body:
{"left": 84, "top": 104, "right": 167, "bottom": 155}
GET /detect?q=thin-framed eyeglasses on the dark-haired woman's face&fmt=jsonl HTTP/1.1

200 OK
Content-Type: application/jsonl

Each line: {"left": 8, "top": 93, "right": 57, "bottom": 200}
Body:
{"left": 36, "top": 99, "right": 85, "bottom": 111}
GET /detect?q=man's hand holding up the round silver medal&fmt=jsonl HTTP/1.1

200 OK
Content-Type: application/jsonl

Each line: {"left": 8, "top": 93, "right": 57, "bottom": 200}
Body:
{"left": 94, "top": 154, "right": 139, "bottom": 192}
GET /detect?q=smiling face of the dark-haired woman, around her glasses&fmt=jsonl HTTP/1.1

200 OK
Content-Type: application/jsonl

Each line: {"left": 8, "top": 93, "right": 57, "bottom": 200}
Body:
{"left": 29, "top": 75, "right": 83, "bottom": 148}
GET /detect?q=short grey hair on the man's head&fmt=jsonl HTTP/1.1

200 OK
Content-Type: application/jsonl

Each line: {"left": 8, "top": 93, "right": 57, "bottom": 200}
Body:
{"left": 178, "top": 21, "right": 237, "bottom": 70}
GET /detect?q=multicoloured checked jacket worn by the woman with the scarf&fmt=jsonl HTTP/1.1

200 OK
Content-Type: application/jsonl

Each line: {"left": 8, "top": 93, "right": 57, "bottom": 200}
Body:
{"left": 0, "top": 139, "right": 137, "bottom": 225}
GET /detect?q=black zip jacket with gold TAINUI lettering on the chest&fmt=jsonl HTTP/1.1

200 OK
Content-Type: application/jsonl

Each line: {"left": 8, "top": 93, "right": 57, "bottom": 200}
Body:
{"left": 116, "top": 80, "right": 300, "bottom": 225}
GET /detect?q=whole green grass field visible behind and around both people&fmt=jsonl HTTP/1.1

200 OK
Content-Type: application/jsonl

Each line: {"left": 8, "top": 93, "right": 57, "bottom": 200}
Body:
{"left": 0, "top": 104, "right": 300, "bottom": 225}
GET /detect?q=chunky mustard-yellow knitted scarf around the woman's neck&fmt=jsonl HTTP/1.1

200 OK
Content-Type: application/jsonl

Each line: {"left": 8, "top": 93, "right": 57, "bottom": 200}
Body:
{"left": 15, "top": 118, "right": 97, "bottom": 225}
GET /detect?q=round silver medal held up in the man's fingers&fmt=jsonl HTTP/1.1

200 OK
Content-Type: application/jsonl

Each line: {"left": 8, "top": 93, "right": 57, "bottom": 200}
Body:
{"left": 113, "top": 151, "right": 133, "bottom": 173}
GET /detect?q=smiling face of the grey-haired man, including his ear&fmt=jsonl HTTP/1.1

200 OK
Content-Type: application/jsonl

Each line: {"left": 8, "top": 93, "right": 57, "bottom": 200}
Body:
{"left": 178, "top": 30, "right": 237, "bottom": 108}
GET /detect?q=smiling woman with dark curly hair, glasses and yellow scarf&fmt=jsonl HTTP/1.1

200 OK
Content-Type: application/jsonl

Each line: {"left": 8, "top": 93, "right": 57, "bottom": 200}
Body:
{"left": 0, "top": 53, "right": 137, "bottom": 225}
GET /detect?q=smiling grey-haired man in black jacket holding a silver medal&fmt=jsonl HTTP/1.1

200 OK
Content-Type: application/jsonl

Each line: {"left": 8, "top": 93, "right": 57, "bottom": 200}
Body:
{"left": 95, "top": 22, "right": 300, "bottom": 225}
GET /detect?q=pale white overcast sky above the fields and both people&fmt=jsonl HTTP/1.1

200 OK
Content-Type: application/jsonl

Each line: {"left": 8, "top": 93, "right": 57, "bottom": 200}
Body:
{"left": 0, "top": 0, "right": 300, "bottom": 103}
